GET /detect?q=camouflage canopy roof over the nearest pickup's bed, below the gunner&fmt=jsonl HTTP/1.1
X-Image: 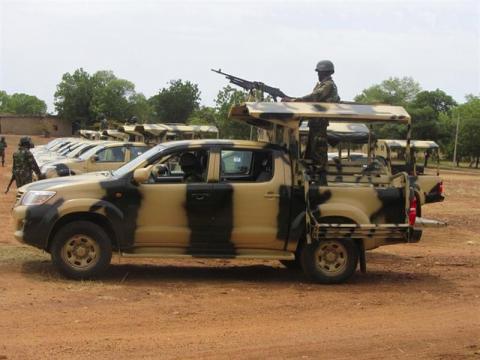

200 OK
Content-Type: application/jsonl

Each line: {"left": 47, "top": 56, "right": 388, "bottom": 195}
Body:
{"left": 229, "top": 102, "right": 410, "bottom": 128}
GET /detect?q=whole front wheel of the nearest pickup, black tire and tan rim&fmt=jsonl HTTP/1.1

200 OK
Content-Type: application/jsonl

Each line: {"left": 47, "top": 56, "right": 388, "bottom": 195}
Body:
{"left": 50, "top": 221, "right": 112, "bottom": 280}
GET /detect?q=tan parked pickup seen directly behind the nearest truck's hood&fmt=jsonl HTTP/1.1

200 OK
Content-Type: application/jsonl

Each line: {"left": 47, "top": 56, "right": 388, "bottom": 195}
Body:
{"left": 40, "top": 141, "right": 149, "bottom": 178}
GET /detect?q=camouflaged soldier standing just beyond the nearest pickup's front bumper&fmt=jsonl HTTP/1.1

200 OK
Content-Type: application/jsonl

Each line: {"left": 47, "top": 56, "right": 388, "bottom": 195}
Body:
{"left": 12, "top": 137, "right": 43, "bottom": 188}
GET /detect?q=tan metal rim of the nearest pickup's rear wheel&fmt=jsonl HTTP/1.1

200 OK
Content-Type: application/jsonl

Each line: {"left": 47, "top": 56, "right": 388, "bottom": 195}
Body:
{"left": 315, "top": 241, "right": 348, "bottom": 276}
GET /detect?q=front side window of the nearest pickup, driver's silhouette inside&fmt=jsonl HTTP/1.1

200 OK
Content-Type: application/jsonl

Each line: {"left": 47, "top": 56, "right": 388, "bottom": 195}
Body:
{"left": 148, "top": 149, "right": 209, "bottom": 184}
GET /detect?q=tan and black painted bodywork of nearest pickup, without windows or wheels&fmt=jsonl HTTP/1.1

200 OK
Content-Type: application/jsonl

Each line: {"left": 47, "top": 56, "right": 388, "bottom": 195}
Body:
{"left": 13, "top": 136, "right": 408, "bottom": 259}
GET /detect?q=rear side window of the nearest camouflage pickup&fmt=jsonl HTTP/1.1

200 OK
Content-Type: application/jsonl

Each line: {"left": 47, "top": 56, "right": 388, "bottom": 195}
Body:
{"left": 220, "top": 150, "right": 273, "bottom": 182}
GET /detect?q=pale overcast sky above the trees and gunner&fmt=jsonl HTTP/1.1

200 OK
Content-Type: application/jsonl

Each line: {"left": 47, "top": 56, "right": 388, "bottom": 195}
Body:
{"left": 0, "top": 0, "right": 480, "bottom": 112}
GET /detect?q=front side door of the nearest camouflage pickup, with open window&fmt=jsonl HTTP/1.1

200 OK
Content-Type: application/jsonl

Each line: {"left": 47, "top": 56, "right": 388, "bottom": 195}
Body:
{"left": 131, "top": 148, "right": 213, "bottom": 250}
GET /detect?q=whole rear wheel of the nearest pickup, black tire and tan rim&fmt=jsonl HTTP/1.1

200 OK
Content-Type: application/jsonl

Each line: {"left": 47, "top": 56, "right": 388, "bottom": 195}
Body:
{"left": 300, "top": 239, "right": 358, "bottom": 284}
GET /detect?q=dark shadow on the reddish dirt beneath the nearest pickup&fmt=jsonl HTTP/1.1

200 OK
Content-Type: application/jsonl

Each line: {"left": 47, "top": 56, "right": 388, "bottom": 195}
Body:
{"left": 17, "top": 260, "right": 453, "bottom": 292}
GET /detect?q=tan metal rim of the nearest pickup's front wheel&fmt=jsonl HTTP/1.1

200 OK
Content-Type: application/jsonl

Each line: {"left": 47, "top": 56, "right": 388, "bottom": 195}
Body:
{"left": 61, "top": 234, "right": 100, "bottom": 271}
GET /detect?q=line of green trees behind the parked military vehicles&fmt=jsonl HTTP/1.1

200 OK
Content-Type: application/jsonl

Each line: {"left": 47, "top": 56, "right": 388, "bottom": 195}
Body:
{"left": 0, "top": 68, "right": 480, "bottom": 167}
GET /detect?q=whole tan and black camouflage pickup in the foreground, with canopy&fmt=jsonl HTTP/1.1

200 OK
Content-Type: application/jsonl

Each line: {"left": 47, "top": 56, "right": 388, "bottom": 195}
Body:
{"left": 13, "top": 103, "right": 442, "bottom": 284}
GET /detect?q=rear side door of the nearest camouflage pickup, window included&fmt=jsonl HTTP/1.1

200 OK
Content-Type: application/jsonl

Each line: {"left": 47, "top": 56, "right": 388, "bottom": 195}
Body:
{"left": 212, "top": 148, "right": 289, "bottom": 251}
